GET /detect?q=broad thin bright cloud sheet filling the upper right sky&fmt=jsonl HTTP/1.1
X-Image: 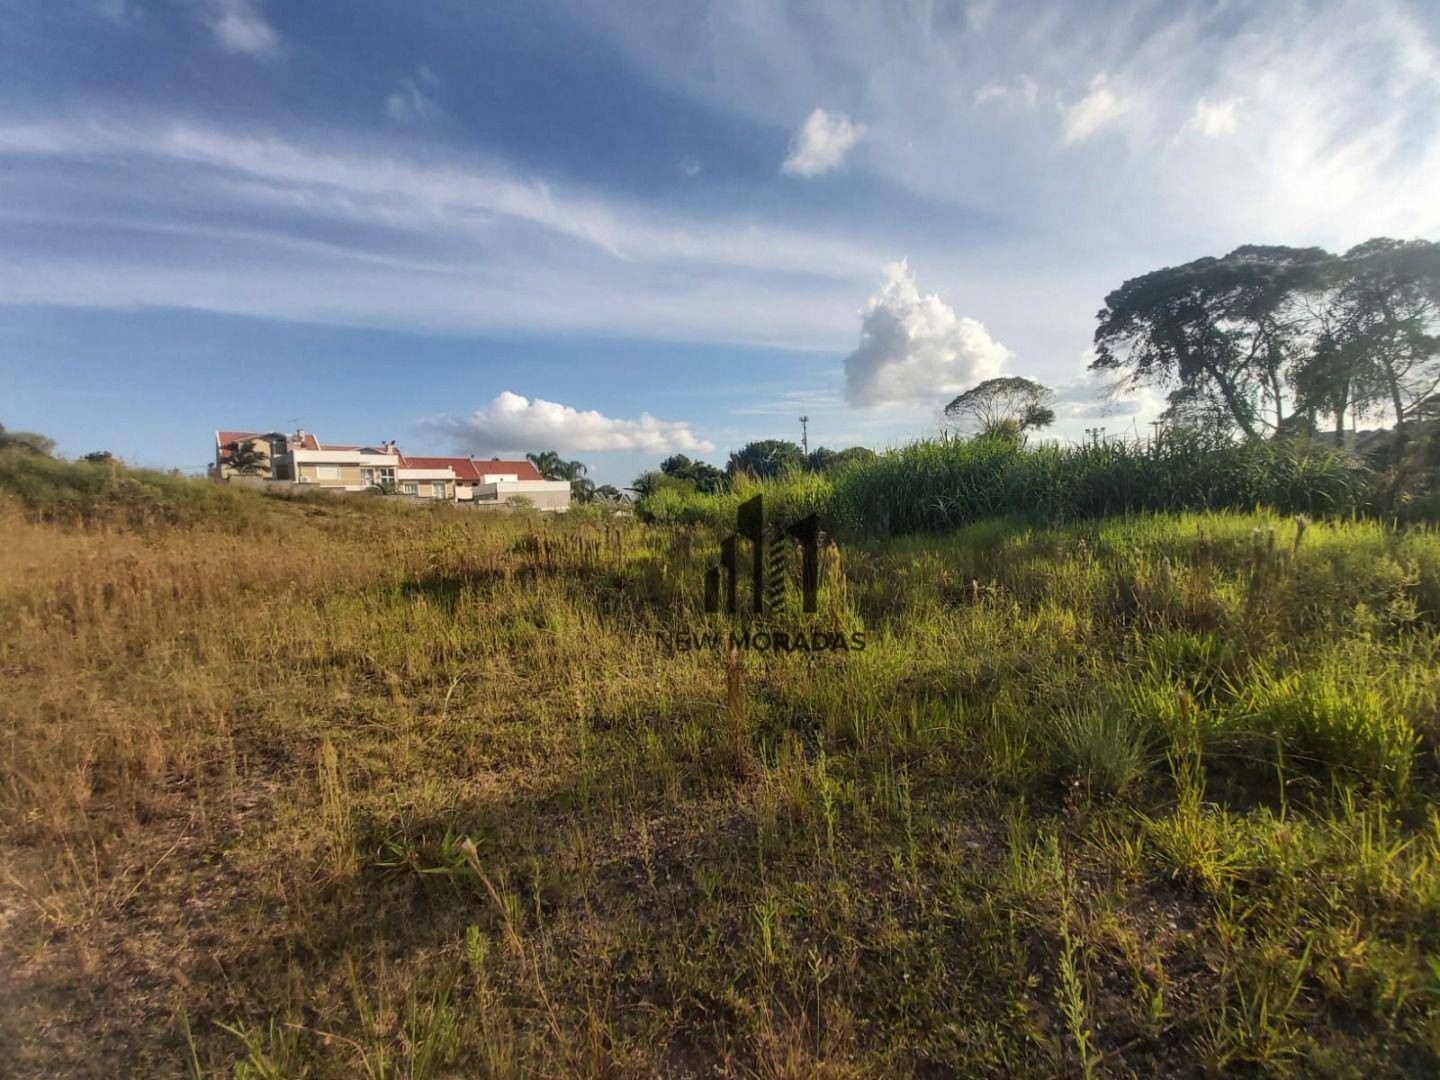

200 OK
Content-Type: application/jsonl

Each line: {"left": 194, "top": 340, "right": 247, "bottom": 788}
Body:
{"left": 586, "top": 0, "right": 1440, "bottom": 244}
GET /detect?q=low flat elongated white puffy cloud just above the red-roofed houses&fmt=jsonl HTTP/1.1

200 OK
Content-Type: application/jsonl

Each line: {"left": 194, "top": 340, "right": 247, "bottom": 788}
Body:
{"left": 422, "top": 390, "right": 714, "bottom": 454}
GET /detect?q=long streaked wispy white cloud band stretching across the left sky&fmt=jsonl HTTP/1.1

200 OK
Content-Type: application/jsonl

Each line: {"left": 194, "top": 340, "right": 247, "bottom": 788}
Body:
{"left": 0, "top": 120, "right": 881, "bottom": 347}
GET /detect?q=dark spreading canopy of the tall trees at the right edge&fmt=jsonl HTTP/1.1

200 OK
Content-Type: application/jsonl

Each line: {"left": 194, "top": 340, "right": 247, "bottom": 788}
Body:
{"left": 1090, "top": 239, "right": 1440, "bottom": 438}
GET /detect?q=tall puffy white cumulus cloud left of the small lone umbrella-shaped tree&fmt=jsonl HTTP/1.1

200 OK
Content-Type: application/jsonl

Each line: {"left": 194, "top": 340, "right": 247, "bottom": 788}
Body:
{"left": 845, "top": 259, "right": 1011, "bottom": 408}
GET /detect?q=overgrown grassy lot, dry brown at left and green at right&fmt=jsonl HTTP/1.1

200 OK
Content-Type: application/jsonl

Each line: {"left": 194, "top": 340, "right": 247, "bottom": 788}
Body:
{"left": 0, "top": 472, "right": 1440, "bottom": 1077}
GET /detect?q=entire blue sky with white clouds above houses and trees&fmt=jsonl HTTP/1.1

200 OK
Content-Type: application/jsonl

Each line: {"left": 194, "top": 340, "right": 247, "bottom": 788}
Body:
{"left": 0, "top": 0, "right": 1440, "bottom": 485}
